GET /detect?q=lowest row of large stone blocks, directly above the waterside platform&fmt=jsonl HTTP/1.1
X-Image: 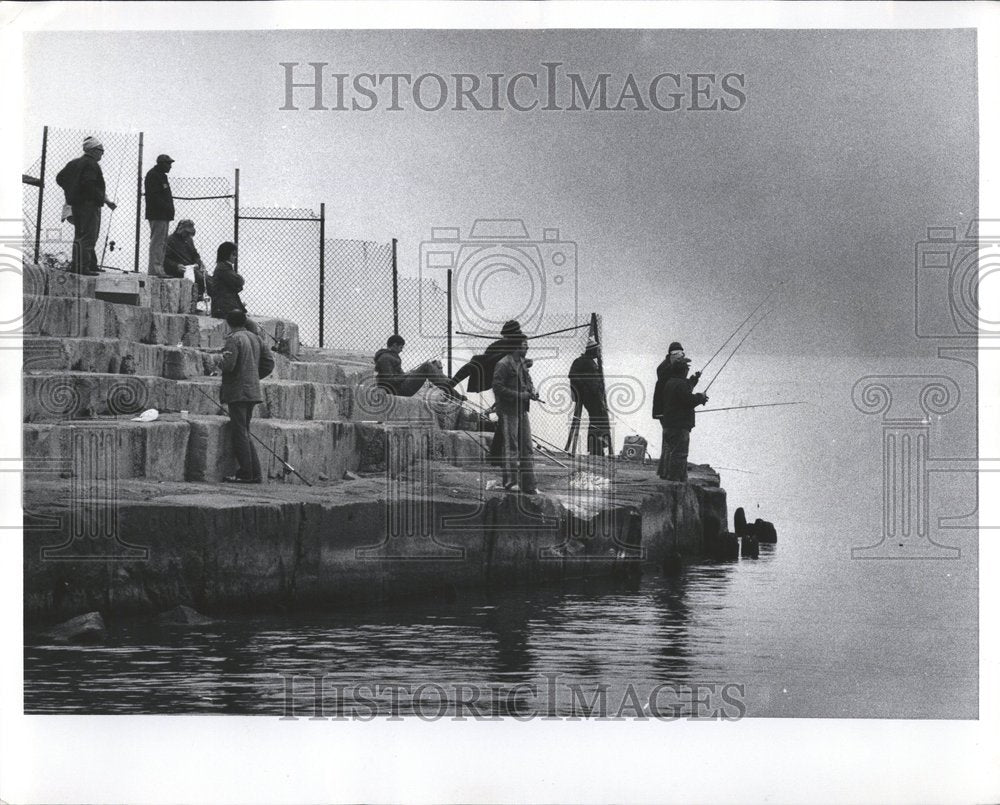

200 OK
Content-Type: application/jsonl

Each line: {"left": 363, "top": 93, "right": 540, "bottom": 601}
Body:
{"left": 23, "top": 415, "right": 484, "bottom": 484}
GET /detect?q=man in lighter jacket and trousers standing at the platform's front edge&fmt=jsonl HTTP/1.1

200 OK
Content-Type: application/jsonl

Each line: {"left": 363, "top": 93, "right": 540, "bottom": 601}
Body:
{"left": 493, "top": 327, "right": 541, "bottom": 495}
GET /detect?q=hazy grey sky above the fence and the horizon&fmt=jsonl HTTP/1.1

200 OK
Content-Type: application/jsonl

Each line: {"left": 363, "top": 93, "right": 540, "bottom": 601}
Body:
{"left": 24, "top": 30, "right": 977, "bottom": 355}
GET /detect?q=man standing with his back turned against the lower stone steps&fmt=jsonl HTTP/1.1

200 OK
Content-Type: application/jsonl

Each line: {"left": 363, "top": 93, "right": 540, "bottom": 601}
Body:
{"left": 219, "top": 310, "right": 274, "bottom": 484}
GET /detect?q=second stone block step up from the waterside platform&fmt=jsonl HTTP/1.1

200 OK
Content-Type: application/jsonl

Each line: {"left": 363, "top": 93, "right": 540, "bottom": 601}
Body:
{"left": 23, "top": 371, "right": 362, "bottom": 422}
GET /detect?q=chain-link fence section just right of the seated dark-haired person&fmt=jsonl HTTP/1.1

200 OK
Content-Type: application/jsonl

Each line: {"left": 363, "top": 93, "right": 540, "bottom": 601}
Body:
{"left": 236, "top": 207, "right": 322, "bottom": 346}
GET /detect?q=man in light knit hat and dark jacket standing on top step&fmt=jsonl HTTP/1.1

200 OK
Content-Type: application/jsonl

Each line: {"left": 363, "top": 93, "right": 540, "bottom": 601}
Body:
{"left": 56, "top": 137, "right": 116, "bottom": 276}
